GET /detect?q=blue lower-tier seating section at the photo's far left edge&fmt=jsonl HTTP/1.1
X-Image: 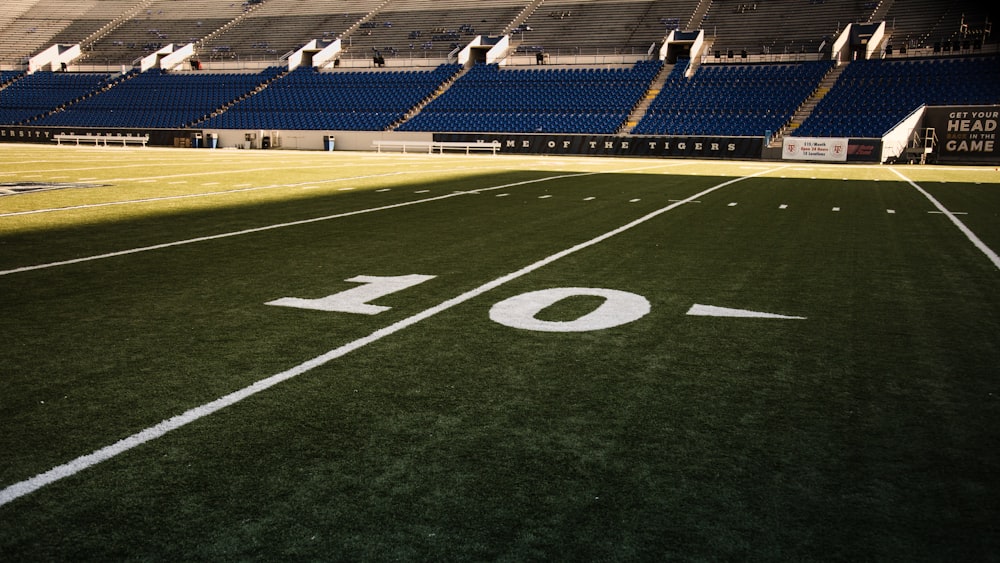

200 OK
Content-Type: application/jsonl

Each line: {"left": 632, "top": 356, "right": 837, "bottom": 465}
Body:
{"left": 0, "top": 71, "right": 111, "bottom": 125}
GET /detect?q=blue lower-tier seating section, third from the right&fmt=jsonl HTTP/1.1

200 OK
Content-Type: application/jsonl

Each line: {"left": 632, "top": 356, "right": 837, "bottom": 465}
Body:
{"left": 400, "top": 61, "right": 662, "bottom": 134}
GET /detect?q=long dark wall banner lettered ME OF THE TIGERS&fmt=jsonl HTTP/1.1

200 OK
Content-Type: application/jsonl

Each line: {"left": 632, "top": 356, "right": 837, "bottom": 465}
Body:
{"left": 434, "top": 133, "right": 764, "bottom": 160}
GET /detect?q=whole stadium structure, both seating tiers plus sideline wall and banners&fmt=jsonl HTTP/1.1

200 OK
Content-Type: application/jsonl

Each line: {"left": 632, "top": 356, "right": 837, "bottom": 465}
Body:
{"left": 0, "top": 0, "right": 1000, "bottom": 164}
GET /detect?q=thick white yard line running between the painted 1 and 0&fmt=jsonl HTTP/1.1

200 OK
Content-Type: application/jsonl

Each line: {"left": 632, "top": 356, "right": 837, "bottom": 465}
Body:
{"left": 0, "top": 163, "right": 783, "bottom": 506}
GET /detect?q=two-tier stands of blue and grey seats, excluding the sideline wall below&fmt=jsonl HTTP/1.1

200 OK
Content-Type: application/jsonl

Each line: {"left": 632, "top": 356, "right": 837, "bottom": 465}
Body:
{"left": 0, "top": 0, "right": 1000, "bottom": 149}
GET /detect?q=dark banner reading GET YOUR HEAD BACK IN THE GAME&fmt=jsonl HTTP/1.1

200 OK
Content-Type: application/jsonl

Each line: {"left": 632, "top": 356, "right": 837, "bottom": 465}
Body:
{"left": 923, "top": 106, "right": 1000, "bottom": 164}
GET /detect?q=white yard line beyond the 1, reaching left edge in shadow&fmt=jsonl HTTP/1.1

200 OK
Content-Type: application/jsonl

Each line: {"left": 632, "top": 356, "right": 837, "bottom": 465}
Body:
{"left": 0, "top": 172, "right": 610, "bottom": 276}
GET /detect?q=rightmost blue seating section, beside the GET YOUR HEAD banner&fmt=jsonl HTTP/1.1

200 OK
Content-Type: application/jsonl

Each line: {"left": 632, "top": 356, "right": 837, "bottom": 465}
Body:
{"left": 793, "top": 57, "right": 1000, "bottom": 137}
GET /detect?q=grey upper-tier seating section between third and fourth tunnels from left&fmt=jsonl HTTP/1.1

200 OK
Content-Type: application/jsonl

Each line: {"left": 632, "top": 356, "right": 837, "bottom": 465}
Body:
{"left": 344, "top": 0, "right": 527, "bottom": 62}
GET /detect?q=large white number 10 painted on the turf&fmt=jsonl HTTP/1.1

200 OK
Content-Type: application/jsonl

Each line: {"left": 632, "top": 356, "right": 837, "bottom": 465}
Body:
{"left": 266, "top": 274, "right": 650, "bottom": 332}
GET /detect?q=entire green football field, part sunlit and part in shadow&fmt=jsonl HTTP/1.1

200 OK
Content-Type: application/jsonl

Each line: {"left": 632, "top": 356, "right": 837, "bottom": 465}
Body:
{"left": 0, "top": 145, "right": 1000, "bottom": 561}
